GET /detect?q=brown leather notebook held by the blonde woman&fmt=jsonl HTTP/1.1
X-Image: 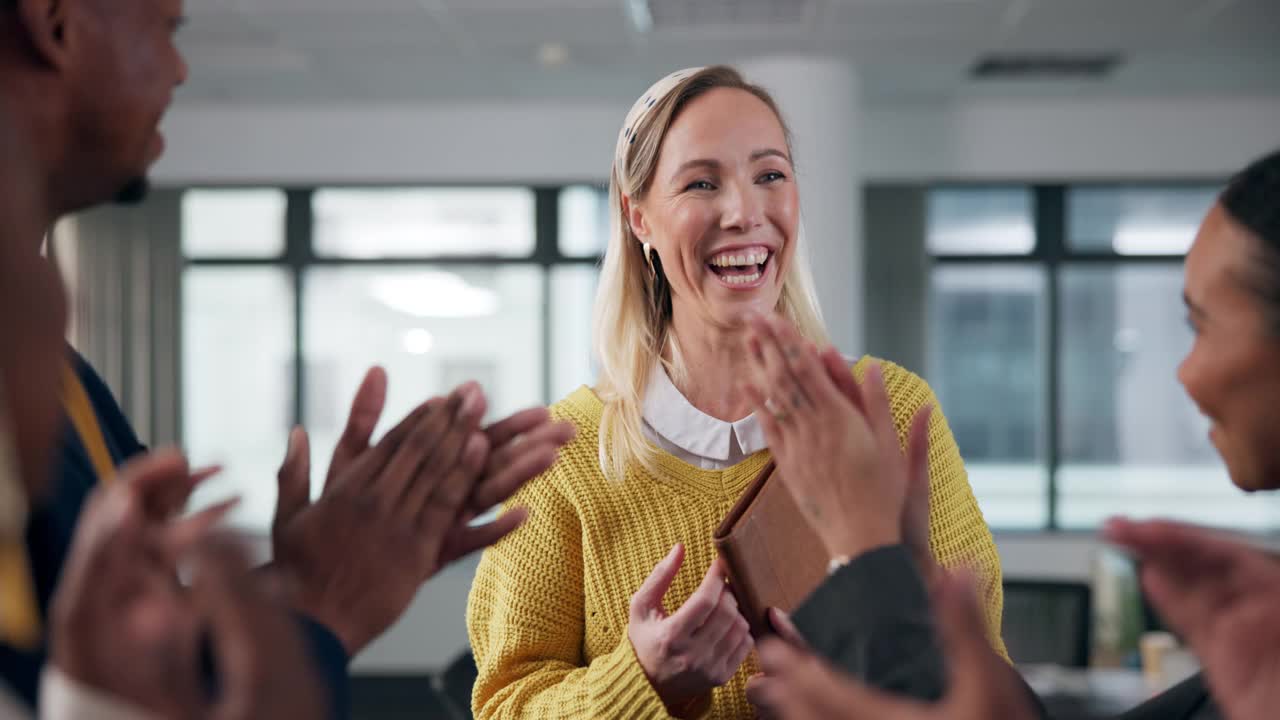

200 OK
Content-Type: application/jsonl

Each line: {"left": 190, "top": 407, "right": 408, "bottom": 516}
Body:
{"left": 714, "top": 462, "right": 827, "bottom": 638}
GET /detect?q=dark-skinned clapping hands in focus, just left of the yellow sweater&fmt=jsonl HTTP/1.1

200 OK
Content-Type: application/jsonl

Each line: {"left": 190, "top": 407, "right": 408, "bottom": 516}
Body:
{"left": 273, "top": 369, "right": 572, "bottom": 655}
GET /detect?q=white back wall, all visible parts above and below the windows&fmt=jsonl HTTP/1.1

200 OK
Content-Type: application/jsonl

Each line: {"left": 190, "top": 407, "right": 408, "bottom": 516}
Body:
{"left": 155, "top": 92, "right": 1280, "bottom": 671}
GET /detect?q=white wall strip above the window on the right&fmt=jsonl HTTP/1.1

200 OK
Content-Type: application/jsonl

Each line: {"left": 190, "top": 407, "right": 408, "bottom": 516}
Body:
{"left": 861, "top": 97, "right": 1280, "bottom": 181}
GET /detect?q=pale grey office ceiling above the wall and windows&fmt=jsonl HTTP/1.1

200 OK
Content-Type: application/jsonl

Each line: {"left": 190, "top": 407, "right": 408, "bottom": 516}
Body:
{"left": 179, "top": 0, "right": 1280, "bottom": 102}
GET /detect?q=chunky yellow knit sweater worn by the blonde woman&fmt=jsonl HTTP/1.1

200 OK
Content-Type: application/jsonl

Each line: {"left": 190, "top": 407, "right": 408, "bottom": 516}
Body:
{"left": 467, "top": 359, "right": 1004, "bottom": 720}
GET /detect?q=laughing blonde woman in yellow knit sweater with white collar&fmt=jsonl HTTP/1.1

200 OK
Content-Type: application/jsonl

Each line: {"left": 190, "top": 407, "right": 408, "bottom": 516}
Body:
{"left": 467, "top": 67, "right": 1002, "bottom": 719}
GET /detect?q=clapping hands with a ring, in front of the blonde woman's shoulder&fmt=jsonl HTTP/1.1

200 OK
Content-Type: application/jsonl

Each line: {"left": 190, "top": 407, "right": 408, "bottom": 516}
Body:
{"left": 744, "top": 311, "right": 932, "bottom": 563}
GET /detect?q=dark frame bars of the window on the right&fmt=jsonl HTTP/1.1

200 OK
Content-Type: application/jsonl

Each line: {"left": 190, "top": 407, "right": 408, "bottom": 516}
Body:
{"left": 927, "top": 178, "right": 1224, "bottom": 532}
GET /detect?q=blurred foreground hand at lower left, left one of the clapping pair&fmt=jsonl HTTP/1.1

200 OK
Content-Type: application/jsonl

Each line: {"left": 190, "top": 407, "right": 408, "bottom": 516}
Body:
{"left": 50, "top": 451, "right": 230, "bottom": 717}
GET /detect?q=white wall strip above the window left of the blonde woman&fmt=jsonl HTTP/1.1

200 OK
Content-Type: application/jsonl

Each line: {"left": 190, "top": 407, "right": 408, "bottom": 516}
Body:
{"left": 155, "top": 102, "right": 626, "bottom": 183}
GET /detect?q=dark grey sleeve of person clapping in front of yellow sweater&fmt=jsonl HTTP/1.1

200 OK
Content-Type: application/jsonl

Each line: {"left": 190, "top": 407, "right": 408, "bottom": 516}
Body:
{"left": 794, "top": 546, "right": 946, "bottom": 700}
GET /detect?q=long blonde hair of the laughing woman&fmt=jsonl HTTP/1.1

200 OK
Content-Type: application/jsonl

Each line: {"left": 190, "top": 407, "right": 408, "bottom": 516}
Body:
{"left": 594, "top": 65, "right": 827, "bottom": 480}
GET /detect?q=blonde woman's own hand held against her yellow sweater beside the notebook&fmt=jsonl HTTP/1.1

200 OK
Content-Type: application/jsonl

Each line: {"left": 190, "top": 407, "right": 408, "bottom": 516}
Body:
{"left": 627, "top": 544, "right": 755, "bottom": 717}
